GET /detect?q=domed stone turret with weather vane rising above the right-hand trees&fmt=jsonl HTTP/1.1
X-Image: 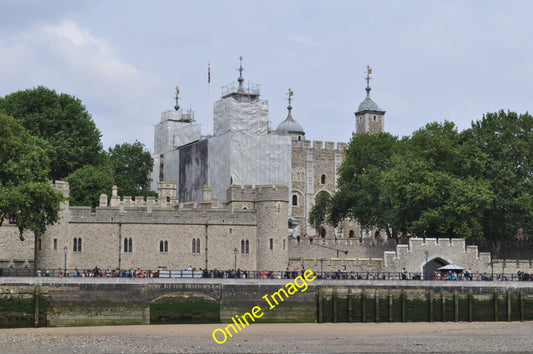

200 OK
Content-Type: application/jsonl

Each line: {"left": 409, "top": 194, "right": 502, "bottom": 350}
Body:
{"left": 355, "top": 66, "right": 385, "bottom": 134}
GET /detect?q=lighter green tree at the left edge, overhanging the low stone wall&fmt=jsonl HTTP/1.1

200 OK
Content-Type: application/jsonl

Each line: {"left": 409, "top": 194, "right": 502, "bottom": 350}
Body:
{"left": 0, "top": 113, "right": 63, "bottom": 240}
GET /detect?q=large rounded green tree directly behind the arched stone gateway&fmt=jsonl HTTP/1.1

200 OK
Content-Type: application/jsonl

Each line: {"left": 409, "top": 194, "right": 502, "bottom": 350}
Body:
{"left": 382, "top": 122, "right": 493, "bottom": 238}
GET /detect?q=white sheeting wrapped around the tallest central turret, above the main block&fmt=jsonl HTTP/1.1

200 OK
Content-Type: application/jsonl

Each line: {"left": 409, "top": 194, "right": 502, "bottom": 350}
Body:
{"left": 213, "top": 97, "right": 268, "bottom": 135}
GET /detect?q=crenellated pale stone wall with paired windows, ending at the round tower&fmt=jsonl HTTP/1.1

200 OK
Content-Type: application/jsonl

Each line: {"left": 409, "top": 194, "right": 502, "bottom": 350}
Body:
{"left": 28, "top": 182, "right": 288, "bottom": 270}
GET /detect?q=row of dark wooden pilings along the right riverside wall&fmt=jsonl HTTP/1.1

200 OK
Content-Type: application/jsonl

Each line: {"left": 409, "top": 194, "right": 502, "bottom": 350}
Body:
{"left": 317, "top": 288, "right": 533, "bottom": 323}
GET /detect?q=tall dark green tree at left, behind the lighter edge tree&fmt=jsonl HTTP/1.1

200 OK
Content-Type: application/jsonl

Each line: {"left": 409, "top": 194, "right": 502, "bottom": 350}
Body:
{"left": 0, "top": 86, "right": 102, "bottom": 180}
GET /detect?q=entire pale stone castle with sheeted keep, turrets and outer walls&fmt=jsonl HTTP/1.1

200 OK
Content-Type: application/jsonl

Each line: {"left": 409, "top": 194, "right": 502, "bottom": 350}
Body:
{"left": 0, "top": 64, "right": 531, "bottom": 272}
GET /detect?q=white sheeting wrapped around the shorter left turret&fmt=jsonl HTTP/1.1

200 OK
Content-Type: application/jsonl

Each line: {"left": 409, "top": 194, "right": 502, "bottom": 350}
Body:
{"left": 154, "top": 111, "right": 202, "bottom": 154}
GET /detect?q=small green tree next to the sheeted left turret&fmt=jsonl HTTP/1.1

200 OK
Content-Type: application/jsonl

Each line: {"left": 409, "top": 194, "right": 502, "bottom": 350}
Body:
{"left": 108, "top": 141, "right": 155, "bottom": 196}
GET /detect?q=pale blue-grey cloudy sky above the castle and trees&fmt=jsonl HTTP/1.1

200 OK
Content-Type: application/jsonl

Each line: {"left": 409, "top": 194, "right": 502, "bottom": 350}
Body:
{"left": 0, "top": 0, "right": 533, "bottom": 151}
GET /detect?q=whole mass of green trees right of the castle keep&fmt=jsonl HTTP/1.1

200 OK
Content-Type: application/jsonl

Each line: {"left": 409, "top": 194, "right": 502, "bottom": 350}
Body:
{"left": 311, "top": 111, "right": 533, "bottom": 239}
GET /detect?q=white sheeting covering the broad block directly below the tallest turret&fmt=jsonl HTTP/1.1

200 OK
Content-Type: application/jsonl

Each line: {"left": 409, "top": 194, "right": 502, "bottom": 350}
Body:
{"left": 209, "top": 132, "right": 292, "bottom": 200}
